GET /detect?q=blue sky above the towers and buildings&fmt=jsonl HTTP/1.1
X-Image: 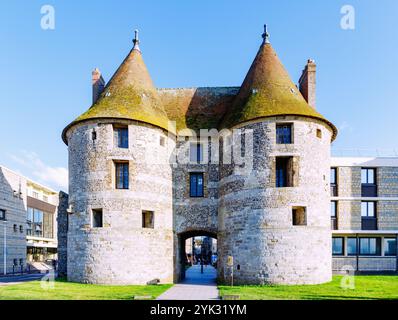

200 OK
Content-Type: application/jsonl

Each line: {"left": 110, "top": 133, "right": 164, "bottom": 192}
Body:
{"left": 0, "top": 0, "right": 398, "bottom": 190}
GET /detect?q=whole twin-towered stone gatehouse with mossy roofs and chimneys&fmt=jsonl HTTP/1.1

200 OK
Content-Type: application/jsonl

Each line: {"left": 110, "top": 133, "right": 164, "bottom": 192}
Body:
{"left": 62, "top": 25, "right": 337, "bottom": 284}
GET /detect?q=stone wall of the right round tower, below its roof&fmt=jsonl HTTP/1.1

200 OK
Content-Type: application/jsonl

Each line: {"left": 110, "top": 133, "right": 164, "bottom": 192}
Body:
{"left": 218, "top": 116, "right": 332, "bottom": 284}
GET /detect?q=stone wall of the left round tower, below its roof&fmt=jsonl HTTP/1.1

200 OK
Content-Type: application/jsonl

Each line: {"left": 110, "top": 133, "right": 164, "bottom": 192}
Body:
{"left": 67, "top": 120, "right": 175, "bottom": 284}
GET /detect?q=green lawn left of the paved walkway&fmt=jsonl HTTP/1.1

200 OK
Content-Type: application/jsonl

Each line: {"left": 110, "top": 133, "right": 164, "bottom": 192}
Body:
{"left": 0, "top": 280, "right": 172, "bottom": 300}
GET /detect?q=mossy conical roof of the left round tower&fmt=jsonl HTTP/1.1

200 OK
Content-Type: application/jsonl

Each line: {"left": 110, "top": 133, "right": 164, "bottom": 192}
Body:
{"left": 63, "top": 33, "right": 169, "bottom": 144}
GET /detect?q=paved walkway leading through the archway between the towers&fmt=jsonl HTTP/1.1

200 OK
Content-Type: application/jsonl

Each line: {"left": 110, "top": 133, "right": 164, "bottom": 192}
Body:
{"left": 157, "top": 265, "right": 219, "bottom": 300}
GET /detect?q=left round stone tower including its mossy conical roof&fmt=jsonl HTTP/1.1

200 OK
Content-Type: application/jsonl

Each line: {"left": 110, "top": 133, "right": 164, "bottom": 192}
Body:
{"left": 63, "top": 32, "right": 175, "bottom": 284}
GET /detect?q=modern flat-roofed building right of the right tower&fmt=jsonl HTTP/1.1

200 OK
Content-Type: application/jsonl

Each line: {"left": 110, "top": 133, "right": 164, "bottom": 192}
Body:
{"left": 330, "top": 157, "right": 398, "bottom": 272}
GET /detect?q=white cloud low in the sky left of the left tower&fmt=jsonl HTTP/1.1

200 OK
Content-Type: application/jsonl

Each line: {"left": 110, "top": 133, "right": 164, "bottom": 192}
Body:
{"left": 9, "top": 150, "right": 68, "bottom": 191}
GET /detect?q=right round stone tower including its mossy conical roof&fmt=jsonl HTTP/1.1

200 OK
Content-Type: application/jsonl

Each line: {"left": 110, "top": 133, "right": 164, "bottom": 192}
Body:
{"left": 218, "top": 27, "right": 337, "bottom": 284}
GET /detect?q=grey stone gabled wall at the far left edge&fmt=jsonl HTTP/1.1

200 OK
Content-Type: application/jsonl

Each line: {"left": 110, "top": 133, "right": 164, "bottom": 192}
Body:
{"left": 0, "top": 167, "right": 27, "bottom": 274}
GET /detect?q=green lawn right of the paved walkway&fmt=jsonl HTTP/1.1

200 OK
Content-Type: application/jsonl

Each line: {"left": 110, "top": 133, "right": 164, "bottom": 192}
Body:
{"left": 219, "top": 276, "right": 398, "bottom": 300}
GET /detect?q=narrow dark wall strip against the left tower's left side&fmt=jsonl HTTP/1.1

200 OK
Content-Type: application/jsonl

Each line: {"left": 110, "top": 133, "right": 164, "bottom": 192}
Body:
{"left": 57, "top": 191, "right": 69, "bottom": 277}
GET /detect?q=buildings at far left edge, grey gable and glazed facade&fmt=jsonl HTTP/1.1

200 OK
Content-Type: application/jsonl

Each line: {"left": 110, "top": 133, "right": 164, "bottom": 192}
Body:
{"left": 0, "top": 166, "right": 58, "bottom": 274}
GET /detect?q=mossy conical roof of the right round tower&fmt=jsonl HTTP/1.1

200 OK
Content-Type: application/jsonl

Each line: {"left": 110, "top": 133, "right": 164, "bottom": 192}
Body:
{"left": 221, "top": 26, "right": 337, "bottom": 139}
